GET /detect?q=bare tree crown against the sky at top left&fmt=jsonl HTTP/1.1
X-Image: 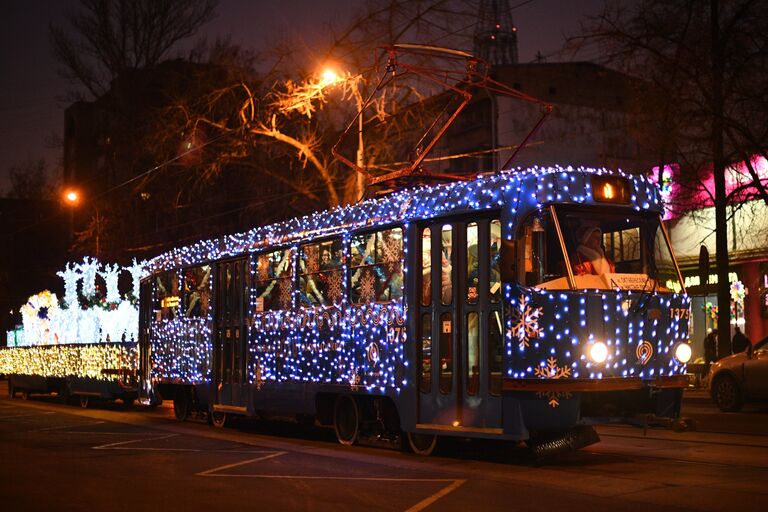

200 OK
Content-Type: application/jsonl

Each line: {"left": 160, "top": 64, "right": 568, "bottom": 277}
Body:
{"left": 50, "top": 0, "right": 216, "bottom": 98}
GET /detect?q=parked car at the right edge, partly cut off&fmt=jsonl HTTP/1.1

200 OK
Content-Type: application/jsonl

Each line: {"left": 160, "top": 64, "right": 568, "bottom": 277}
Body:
{"left": 709, "top": 337, "right": 768, "bottom": 412}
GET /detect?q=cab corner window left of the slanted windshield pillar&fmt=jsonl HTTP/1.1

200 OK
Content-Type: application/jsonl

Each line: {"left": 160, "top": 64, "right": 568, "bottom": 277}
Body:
{"left": 518, "top": 211, "right": 568, "bottom": 288}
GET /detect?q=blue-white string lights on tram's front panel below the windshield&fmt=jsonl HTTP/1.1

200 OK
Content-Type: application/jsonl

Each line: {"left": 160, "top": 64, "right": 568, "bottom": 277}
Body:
{"left": 505, "top": 285, "right": 690, "bottom": 379}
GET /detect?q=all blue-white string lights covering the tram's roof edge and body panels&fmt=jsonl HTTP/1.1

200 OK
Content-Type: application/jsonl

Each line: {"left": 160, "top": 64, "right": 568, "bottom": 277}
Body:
{"left": 147, "top": 167, "right": 690, "bottom": 400}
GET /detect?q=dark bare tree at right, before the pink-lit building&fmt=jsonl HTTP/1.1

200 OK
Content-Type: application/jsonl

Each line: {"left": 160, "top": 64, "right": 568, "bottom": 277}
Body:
{"left": 570, "top": 0, "right": 768, "bottom": 356}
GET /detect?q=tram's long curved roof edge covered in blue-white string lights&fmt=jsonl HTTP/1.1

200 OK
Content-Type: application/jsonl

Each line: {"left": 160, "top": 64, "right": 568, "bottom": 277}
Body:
{"left": 147, "top": 166, "right": 662, "bottom": 272}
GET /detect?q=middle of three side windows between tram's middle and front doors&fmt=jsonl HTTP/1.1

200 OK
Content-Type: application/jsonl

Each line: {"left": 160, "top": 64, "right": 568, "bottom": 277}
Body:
{"left": 299, "top": 238, "right": 343, "bottom": 307}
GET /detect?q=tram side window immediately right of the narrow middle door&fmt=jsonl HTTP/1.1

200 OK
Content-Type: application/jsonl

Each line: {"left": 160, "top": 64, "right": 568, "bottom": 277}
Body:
{"left": 255, "top": 249, "right": 293, "bottom": 312}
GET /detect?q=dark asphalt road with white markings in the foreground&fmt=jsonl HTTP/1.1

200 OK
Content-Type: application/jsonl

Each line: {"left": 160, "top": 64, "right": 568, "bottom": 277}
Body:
{"left": 0, "top": 383, "right": 768, "bottom": 512}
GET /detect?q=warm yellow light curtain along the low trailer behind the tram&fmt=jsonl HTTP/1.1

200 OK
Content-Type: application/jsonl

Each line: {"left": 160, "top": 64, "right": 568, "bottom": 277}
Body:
{"left": 0, "top": 343, "right": 139, "bottom": 380}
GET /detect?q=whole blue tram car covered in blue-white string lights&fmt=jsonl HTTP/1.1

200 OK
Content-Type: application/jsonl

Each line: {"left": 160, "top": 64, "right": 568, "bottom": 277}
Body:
{"left": 140, "top": 167, "right": 690, "bottom": 454}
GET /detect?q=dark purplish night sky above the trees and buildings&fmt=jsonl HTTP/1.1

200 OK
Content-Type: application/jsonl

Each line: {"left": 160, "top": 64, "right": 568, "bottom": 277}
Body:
{"left": 0, "top": 0, "right": 603, "bottom": 195}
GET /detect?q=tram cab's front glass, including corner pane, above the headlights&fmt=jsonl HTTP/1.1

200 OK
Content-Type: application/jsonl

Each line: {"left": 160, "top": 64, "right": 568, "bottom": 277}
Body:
{"left": 518, "top": 207, "right": 682, "bottom": 292}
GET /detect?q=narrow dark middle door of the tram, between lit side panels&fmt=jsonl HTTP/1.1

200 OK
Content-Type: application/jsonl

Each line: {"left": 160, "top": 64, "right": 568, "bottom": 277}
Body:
{"left": 214, "top": 258, "right": 250, "bottom": 406}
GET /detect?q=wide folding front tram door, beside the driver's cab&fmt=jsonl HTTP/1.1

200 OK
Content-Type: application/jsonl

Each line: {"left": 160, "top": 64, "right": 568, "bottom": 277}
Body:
{"left": 418, "top": 218, "right": 503, "bottom": 431}
